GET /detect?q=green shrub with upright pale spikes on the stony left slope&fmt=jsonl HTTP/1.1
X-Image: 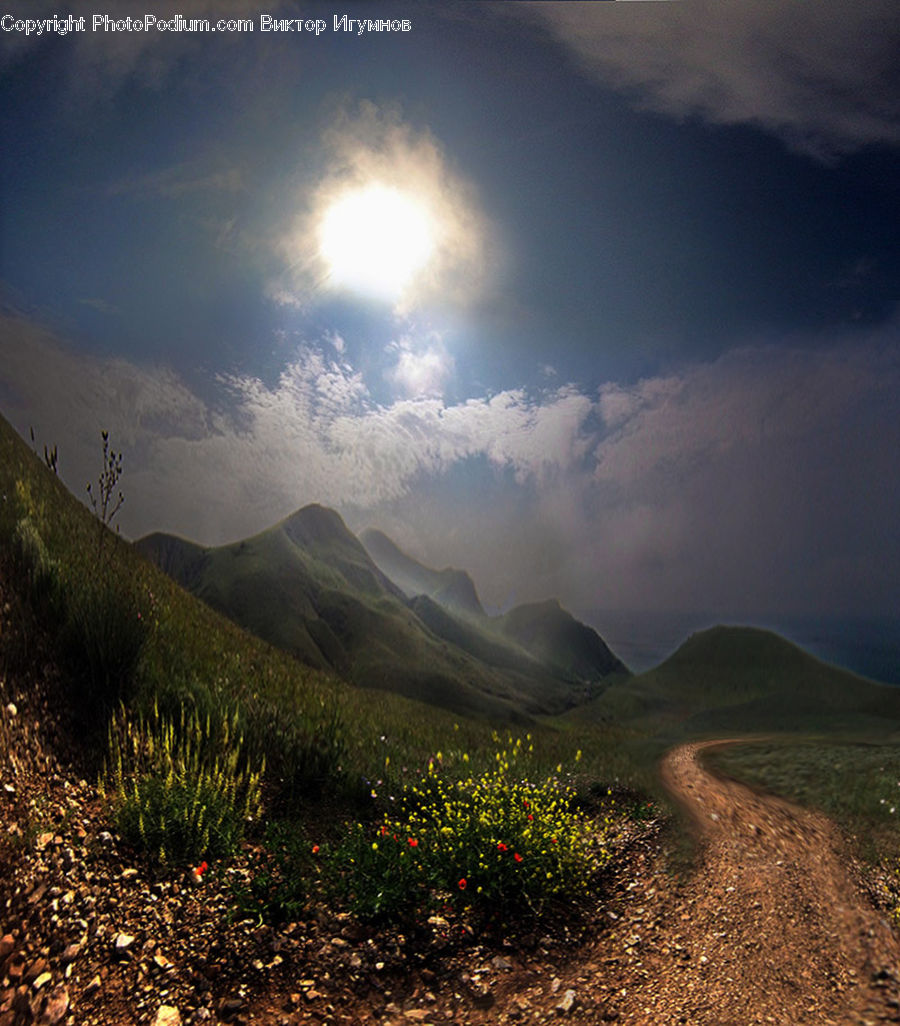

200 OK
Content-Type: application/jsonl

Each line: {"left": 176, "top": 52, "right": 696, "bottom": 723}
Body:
{"left": 106, "top": 707, "right": 264, "bottom": 865}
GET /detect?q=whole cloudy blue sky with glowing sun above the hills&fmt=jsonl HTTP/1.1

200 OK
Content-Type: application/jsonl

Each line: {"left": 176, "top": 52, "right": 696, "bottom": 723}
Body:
{"left": 0, "top": 0, "right": 900, "bottom": 619}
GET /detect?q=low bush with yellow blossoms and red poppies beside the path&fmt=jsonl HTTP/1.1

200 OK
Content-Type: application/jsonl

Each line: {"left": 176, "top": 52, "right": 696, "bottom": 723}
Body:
{"left": 325, "top": 741, "right": 609, "bottom": 919}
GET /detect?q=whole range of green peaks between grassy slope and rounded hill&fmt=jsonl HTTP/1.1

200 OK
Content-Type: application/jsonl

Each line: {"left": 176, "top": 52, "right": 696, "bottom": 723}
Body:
{"left": 134, "top": 505, "right": 628, "bottom": 719}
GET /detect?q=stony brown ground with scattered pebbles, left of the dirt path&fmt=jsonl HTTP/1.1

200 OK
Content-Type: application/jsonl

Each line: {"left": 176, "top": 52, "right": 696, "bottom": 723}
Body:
{"left": 0, "top": 656, "right": 655, "bottom": 1026}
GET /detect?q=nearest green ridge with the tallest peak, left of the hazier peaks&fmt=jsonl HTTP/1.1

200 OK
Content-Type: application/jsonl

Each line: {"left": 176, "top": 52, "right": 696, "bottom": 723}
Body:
{"left": 135, "top": 505, "right": 611, "bottom": 719}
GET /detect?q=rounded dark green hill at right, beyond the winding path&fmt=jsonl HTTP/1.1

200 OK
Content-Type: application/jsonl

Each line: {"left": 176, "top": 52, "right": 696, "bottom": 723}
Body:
{"left": 572, "top": 627, "right": 900, "bottom": 739}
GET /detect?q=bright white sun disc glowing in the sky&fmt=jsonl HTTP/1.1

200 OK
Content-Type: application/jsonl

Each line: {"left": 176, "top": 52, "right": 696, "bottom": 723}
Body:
{"left": 319, "top": 185, "right": 434, "bottom": 302}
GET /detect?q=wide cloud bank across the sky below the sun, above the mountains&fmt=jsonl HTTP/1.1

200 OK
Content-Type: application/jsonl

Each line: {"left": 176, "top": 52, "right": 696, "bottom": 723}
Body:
{"left": 0, "top": 307, "right": 900, "bottom": 614}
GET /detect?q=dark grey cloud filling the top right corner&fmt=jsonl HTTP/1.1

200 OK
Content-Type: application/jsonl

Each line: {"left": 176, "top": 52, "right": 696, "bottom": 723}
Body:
{"left": 515, "top": 0, "right": 900, "bottom": 159}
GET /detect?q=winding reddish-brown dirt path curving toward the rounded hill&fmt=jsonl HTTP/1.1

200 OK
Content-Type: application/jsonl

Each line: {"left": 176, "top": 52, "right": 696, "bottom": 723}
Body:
{"left": 632, "top": 742, "right": 900, "bottom": 1026}
